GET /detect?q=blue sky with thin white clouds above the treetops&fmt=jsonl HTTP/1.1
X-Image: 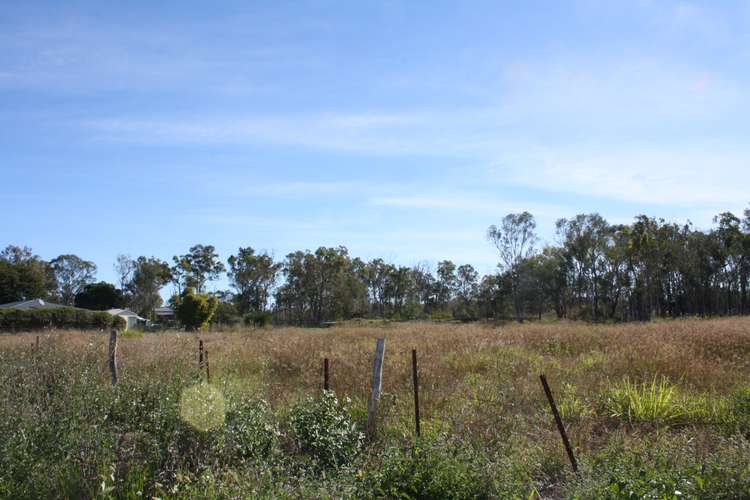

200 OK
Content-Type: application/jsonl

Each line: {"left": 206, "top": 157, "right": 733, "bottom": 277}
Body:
{"left": 0, "top": 1, "right": 750, "bottom": 286}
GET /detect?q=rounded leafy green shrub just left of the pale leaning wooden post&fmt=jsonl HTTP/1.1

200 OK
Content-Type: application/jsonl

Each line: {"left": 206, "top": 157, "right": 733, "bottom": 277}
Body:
{"left": 290, "top": 391, "right": 364, "bottom": 468}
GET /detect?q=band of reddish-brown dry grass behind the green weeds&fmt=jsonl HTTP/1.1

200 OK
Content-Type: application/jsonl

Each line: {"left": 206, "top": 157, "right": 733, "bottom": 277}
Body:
{"left": 0, "top": 318, "right": 750, "bottom": 430}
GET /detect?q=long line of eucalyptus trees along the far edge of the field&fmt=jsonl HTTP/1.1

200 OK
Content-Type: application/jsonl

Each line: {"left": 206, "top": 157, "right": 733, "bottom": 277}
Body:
{"left": 0, "top": 205, "right": 750, "bottom": 327}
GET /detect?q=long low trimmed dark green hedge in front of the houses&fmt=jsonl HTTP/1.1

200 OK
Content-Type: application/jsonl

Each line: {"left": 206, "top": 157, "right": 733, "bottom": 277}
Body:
{"left": 0, "top": 307, "right": 126, "bottom": 332}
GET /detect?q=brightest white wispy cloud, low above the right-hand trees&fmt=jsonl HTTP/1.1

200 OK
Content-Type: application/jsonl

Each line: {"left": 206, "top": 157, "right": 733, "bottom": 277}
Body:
{"left": 495, "top": 144, "right": 750, "bottom": 207}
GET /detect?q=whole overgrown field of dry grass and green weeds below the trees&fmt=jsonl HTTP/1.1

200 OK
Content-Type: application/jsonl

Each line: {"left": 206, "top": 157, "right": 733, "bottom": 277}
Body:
{"left": 0, "top": 319, "right": 750, "bottom": 498}
